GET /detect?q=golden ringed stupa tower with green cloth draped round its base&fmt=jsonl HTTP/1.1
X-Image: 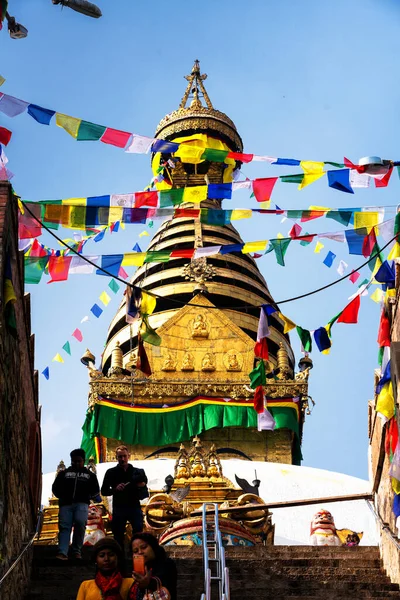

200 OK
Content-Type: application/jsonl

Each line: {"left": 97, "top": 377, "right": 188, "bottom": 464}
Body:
{"left": 82, "top": 60, "right": 312, "bottom": 472}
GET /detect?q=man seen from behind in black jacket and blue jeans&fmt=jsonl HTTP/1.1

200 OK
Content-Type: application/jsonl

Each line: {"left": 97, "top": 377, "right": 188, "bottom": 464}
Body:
{"left": 52, "top": 448, "right": 100, "bottom": 560}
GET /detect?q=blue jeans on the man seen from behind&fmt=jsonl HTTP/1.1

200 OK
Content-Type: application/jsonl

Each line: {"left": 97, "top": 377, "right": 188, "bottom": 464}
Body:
{"left": 58, "top": 502, "right": 88, "bottom": 556}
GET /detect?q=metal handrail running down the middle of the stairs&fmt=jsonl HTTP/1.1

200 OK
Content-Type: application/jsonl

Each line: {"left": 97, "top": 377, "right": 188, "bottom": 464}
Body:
{"left": 201, "top": 502, "right": 230, "bottom": 600}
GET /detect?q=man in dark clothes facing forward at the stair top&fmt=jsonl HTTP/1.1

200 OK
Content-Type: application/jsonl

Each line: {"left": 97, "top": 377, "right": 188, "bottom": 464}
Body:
{"left": 101, "top": 446, "right": 149, "bottom": 548}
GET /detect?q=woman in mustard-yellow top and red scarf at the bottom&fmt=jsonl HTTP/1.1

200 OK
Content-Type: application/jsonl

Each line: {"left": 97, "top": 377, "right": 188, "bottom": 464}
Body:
{"left": 76, "top": 537, "right": 133, "bottom": 600}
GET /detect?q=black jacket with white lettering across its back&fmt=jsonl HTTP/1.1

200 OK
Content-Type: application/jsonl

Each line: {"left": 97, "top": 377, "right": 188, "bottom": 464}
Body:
{"left": 51, "top": 467, "right": 99, "bottom": 506}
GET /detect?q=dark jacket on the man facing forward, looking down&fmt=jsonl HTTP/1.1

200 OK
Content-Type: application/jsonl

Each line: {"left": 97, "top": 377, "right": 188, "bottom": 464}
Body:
{"left": 101, "top": 464, "right": 149, "bottom": 507}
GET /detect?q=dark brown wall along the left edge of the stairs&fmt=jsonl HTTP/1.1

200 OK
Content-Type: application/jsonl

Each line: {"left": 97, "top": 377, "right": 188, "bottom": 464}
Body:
{"left": 0, "top": 182, "right": 41, "bottom": 600}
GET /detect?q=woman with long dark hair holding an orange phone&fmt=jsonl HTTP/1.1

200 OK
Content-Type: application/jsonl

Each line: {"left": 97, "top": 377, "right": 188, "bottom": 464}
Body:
{"left": 128, "top": 533, "right": 177, "bottom": 600}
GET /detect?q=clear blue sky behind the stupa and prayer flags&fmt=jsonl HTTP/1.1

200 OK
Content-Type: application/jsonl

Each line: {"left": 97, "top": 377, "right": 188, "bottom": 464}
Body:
{"left": 0, "top": 0, "right": 400, "bottom": 477}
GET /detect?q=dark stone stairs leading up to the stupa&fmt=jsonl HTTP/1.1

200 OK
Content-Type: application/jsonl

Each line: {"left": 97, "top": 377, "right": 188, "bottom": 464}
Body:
{"left": 25, "top": 546, "right": 400, "bottom": 600}
